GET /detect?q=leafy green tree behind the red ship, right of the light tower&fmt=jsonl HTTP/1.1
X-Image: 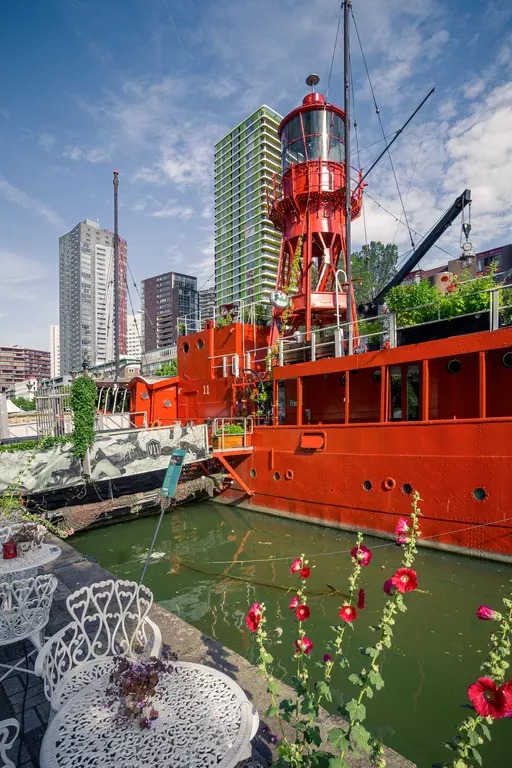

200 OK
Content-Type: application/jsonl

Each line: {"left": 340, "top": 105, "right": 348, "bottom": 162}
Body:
{"left": 352, "top": 240, "right": 398, "bottom": 304}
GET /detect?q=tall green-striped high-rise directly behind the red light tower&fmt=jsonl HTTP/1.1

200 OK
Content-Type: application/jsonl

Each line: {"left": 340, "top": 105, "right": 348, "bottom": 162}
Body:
{"left": 215, "top": 106, "right": 282, "bottom": 305}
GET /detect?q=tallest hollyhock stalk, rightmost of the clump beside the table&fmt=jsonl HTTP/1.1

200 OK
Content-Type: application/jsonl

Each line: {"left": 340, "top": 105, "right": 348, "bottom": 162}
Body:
{"left": 340, "top": 491, "right": 421, "bottom": 768}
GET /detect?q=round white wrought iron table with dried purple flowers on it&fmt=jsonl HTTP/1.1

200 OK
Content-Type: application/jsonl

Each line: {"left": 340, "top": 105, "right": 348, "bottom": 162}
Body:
{"left": 40, "top": 662, "right": 259, "bottom": 768}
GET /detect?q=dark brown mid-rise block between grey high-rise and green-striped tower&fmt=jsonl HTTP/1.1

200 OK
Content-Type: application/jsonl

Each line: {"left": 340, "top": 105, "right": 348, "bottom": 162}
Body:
{"left": 141, "top": 272, "right": 199, "bottom": 352}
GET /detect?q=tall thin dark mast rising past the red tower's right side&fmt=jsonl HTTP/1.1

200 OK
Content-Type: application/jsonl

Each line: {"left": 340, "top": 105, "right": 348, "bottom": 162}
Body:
{"left": 343, "top": 0, "right": 354, "bottom": 355}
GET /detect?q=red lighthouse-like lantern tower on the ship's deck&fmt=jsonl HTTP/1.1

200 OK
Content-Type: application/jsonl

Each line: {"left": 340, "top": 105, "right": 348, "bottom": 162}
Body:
{"left": 267, "top": 75, "right": 363, "bottom": 341}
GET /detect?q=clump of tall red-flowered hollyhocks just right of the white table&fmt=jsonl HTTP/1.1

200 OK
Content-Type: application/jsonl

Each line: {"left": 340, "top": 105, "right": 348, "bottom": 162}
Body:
{"left": 246, "top": 492, "right": 420, "bottom": 768}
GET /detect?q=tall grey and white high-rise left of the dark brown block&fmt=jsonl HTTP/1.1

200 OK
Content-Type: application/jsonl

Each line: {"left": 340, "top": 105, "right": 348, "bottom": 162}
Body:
{"left": 59, "top": 219, "right": 126, "bottom": 375}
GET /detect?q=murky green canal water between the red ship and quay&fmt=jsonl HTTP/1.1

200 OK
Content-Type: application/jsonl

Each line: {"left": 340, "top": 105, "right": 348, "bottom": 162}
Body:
{"left": 72, "top": 502, "right": 512, "bottom": 768}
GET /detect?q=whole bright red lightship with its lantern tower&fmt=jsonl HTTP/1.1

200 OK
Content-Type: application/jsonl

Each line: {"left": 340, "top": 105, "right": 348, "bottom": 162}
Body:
{"left": 130, "top": 81, "right": 512, "bottom": 559}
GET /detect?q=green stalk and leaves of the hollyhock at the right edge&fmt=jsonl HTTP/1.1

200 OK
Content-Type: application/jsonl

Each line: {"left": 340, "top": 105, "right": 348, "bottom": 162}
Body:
{"left": 445, "top": 595, "right": 512, "bottom": 768}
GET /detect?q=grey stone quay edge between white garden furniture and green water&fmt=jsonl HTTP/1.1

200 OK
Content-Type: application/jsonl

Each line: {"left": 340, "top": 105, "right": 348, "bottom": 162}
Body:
{"left": 39, "top": 540, "right": 415, "bottom": 768}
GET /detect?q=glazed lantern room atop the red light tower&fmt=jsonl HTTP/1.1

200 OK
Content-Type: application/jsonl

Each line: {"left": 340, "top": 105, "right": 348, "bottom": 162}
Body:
{"left": 281, "top": 108, "right": 345, "bottom": 171}
